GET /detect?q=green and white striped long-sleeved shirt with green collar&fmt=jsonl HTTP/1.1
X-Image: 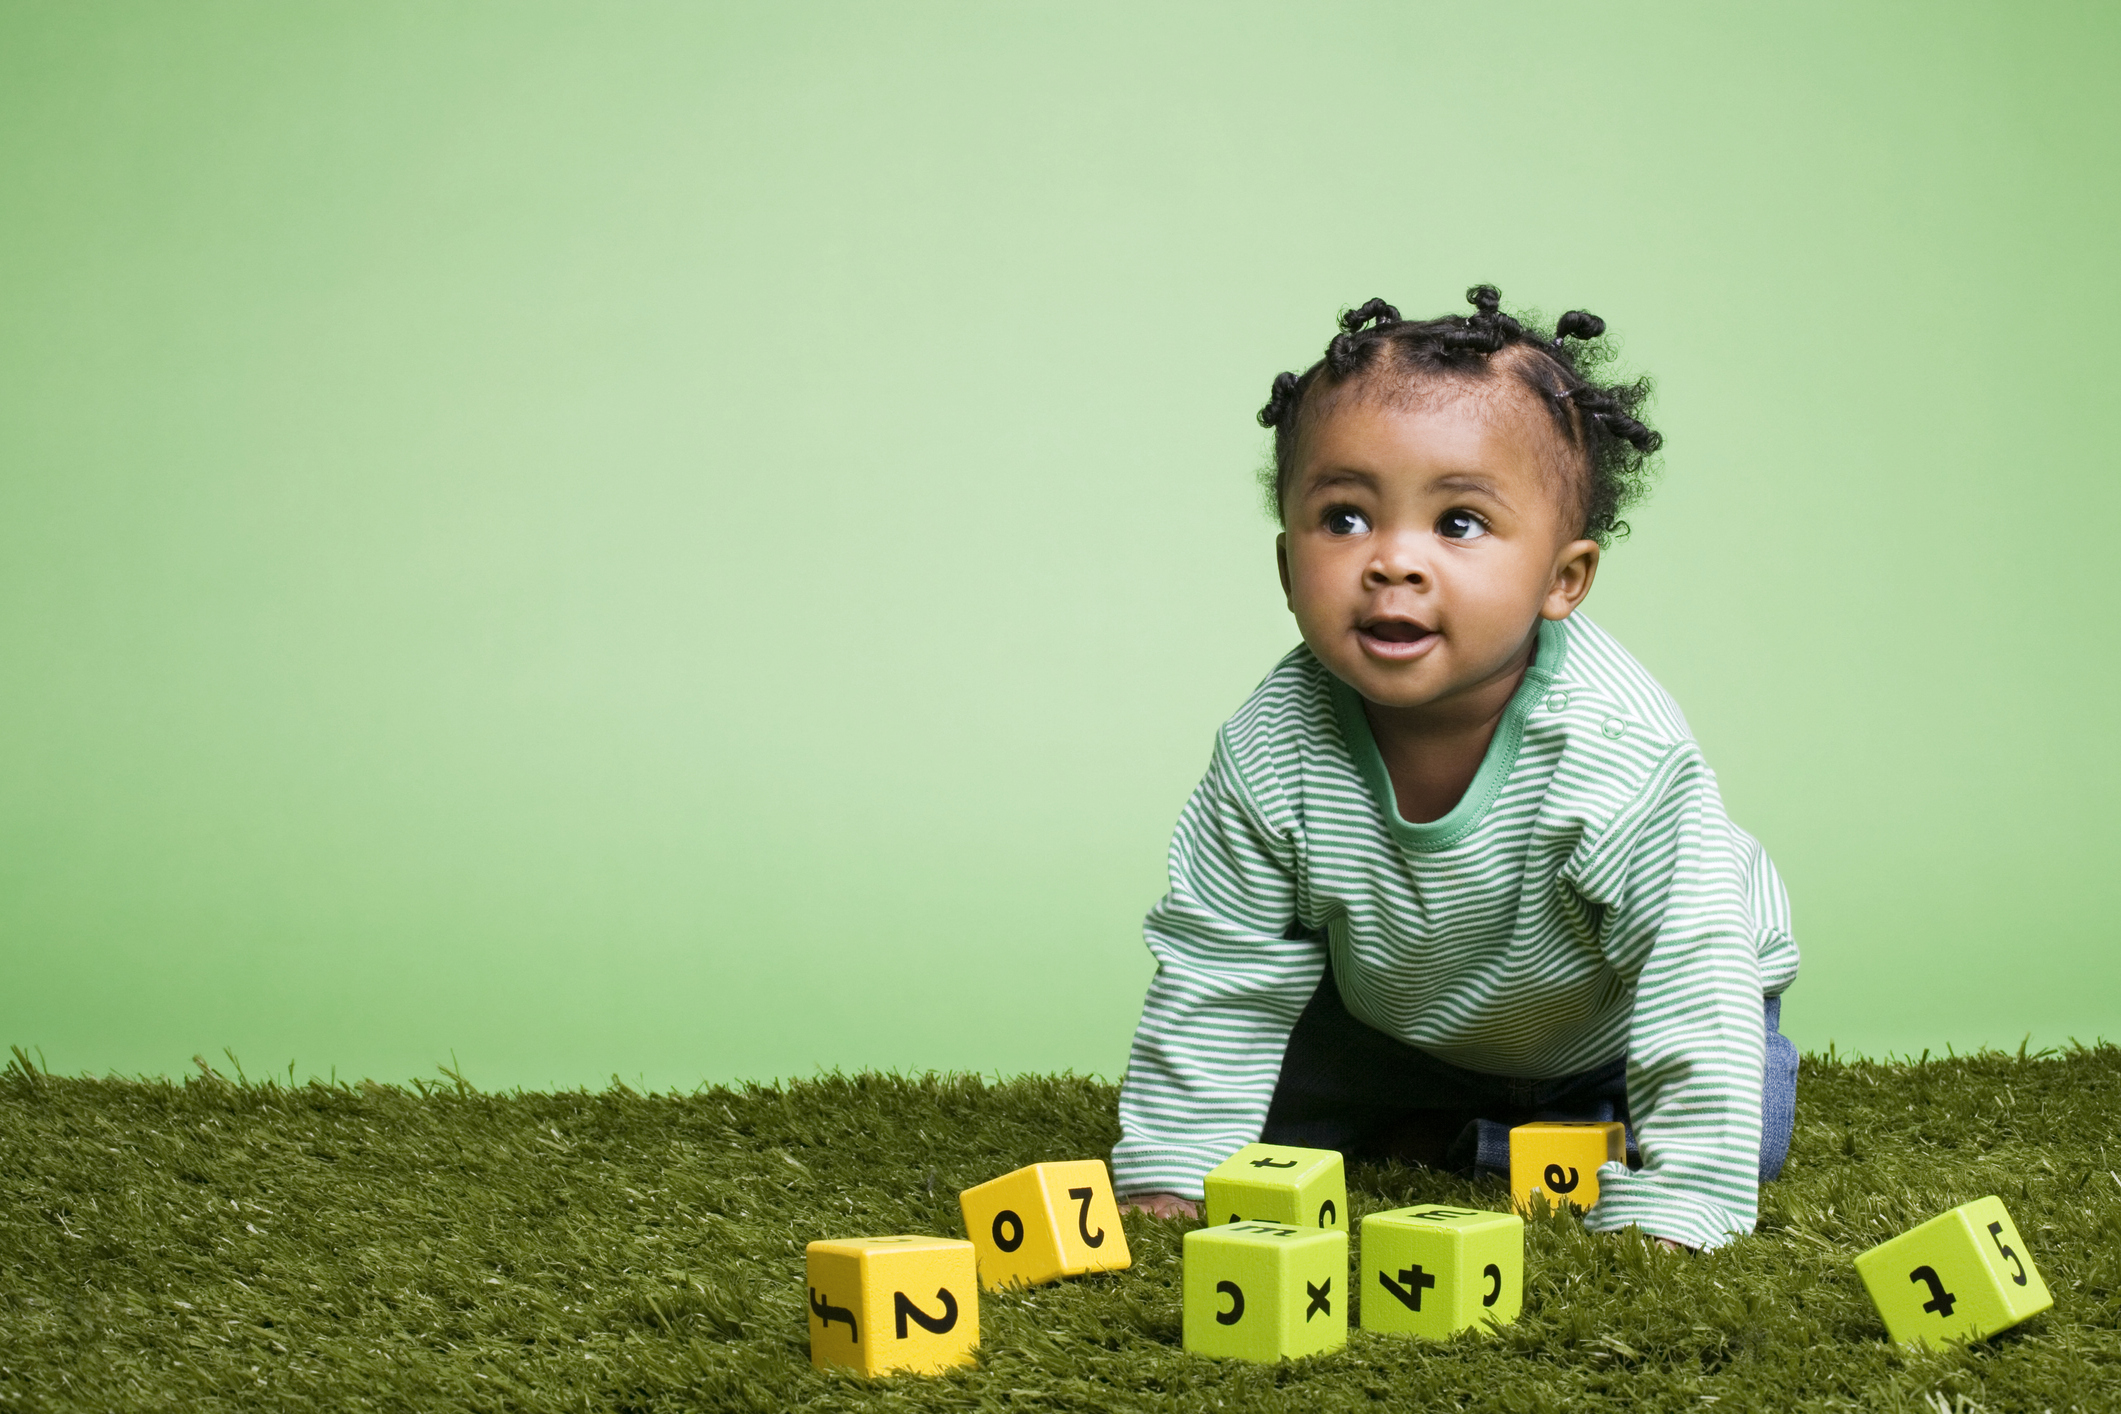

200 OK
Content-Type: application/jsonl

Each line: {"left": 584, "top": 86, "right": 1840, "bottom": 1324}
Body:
{"left": 1111, "top": 615, "right": 1796, "bottom": 1247}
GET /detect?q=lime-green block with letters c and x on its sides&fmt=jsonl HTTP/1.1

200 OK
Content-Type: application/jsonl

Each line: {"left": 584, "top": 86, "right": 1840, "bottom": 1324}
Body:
{"left": 1186, "top": 1223, "right": 1347, "bottom": 1361}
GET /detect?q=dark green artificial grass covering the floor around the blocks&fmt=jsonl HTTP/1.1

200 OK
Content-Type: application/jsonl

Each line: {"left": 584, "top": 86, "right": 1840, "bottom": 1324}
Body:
{"left": 0, "top": 1045, "right": 2121, "bottom": 1414}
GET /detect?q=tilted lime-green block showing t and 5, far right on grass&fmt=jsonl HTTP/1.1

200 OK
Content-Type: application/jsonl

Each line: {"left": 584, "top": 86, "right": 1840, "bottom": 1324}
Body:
{"left": 1856, "top": 1196, "right": 2055, "bottom": 1348}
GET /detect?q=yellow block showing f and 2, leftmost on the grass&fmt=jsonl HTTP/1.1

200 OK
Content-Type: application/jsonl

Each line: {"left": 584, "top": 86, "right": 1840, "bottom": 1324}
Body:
{"left": 806, "top": 1236, "right": 980, "bottom": 1376}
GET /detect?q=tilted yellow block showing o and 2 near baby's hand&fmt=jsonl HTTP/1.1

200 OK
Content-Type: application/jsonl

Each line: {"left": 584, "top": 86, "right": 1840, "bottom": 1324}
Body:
{"left": 957, "top": 1160, "right": 1135, "bottom": 1291}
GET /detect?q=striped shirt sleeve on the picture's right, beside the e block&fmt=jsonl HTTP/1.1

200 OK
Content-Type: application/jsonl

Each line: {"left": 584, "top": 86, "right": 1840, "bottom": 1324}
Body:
{"left": 1578, "top": 746, "right": 1788, "bottom": 1249}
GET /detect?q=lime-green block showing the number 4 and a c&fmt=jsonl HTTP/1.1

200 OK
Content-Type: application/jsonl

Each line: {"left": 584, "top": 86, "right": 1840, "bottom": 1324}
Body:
{"left": 1362, "top": 1202, "right": 1525, "bottom": 1340}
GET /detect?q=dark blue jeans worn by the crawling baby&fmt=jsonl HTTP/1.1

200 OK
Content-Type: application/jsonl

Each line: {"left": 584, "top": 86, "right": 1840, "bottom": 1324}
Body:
{"left": 1260, "top": 967, "right": 1796, "bottom": 1183}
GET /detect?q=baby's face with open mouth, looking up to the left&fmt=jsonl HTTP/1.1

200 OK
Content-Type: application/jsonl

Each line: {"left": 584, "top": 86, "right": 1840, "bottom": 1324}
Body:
{"left": 1279, "top": 386, "right": 1597, "bottom": 708}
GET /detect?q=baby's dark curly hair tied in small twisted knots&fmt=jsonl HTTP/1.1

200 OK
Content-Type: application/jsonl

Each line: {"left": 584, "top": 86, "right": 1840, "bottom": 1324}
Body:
{"left": 1260, "top": 284, "right": 1665, "bottom": 545}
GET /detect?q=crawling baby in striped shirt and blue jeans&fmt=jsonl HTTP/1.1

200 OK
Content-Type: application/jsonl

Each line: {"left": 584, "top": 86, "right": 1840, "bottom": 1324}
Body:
{"left": 1114, "top": 284, "right": 1796, "bottom": 1249}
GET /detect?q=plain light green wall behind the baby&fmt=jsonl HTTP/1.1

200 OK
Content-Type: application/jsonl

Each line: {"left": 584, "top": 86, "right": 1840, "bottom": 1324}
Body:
{"left": 0, "top": 0, "right": 2121, "bottom": 1085}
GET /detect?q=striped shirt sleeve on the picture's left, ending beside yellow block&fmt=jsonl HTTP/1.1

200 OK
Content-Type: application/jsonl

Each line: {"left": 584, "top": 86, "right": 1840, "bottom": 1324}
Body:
{"left": 1111, "top": 742, "right": 1326, "bottom": 1198}
